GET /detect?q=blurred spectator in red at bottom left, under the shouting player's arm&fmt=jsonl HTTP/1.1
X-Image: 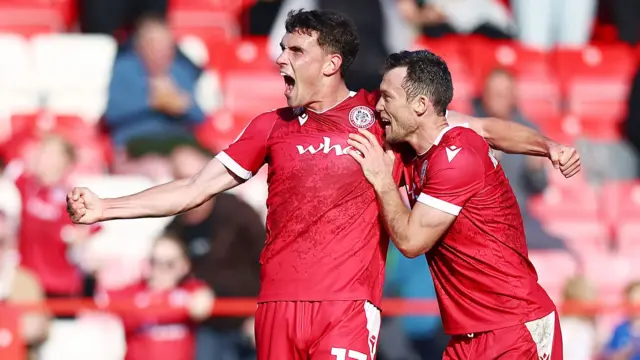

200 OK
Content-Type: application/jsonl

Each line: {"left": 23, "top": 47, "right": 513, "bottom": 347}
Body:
{"left": 99, "top": 236, "right": 214, "bottom": 360}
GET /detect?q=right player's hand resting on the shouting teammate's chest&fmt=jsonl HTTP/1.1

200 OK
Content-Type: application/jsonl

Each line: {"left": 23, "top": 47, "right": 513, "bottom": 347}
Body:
{"left": 347, "top": 129, "right": 396, "bottom": 189}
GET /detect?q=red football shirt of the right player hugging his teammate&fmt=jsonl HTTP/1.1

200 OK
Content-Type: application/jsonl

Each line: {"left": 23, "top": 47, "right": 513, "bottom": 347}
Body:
{"left": 408, "top": 126, "right": 555, "bottom": 334}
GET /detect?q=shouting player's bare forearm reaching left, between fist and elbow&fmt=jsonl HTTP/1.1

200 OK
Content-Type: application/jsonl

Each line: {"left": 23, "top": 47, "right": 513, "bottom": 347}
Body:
{"left": 102, "top": 179, "right": 207, "bottom": 221}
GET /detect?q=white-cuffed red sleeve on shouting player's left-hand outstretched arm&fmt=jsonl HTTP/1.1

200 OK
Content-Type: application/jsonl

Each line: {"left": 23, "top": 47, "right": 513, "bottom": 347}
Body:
{"left": 216, "top": 112, "right": 277, "bottom": 180}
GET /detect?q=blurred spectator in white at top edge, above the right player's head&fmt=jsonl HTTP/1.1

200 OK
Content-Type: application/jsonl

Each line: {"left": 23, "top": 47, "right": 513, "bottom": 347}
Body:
{"left": 398, "top": 0, "right": 515, "bottom": 39}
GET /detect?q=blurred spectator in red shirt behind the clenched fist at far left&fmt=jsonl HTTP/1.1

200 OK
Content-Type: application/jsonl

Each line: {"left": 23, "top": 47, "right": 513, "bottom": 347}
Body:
{"left": 5, "top": 135, "right": 100, "bottom": 297}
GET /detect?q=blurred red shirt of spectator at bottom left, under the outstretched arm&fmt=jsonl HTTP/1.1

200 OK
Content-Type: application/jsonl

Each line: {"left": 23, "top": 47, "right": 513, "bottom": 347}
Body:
{"left": 101, "top": 278, "right": 206, "bottom": 360}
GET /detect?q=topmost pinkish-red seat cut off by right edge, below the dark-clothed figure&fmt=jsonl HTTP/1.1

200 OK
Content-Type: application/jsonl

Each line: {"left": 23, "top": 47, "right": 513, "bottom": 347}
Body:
{"left": 600, "top": 181, "right": 640, "bottom": 224}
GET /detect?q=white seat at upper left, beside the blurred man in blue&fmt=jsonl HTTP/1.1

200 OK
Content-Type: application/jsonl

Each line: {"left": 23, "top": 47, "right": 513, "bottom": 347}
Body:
{"left": 32, "top": 34, "right": 116, "bottom": 94}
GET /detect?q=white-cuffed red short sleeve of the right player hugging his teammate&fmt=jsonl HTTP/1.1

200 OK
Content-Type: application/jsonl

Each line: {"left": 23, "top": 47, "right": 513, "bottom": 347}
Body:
{"left": 418, "top": 146, "right": 485, "bottom": 216}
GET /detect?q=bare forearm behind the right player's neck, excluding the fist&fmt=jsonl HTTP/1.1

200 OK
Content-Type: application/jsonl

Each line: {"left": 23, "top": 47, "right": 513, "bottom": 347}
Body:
{"left": 481, "top": 118, "right": 555, "bottom": 157}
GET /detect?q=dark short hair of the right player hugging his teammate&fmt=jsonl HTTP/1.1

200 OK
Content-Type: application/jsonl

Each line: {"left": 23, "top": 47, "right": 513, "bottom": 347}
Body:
{"left": 383, "top": 50, "right": 453, "bottom": 115}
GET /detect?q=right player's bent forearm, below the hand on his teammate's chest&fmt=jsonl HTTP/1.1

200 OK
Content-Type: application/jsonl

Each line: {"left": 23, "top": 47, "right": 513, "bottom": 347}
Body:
{"left": 376, "top": 183, "right": 420, "bottom": 257}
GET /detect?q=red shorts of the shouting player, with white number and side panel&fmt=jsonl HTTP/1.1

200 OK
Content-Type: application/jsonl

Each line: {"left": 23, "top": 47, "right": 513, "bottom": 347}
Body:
{"left": 256, "top": 301, "right": 380, "bottom": 360}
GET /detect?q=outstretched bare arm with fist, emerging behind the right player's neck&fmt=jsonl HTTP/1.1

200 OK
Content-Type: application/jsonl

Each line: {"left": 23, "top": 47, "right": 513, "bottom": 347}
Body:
{"left": 447, "top": 111, "right": 580, "bottom": 177}
